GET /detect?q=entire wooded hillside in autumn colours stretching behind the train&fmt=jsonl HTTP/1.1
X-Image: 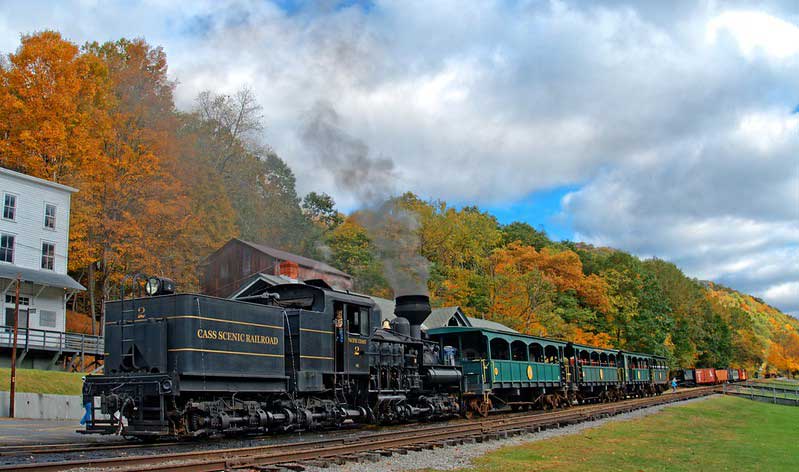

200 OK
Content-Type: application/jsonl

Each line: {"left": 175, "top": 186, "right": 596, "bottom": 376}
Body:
{"left": 0, "top": 32, "right": 799, "bottom": 372}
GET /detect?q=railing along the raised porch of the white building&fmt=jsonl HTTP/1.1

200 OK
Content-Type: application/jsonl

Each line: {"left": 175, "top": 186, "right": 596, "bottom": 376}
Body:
{"left": 0, "top": 326, "right": 104, "bottom": 355}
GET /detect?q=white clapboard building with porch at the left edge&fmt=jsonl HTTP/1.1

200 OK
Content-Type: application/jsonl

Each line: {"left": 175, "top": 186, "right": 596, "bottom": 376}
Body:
{"left": 0, "top": 167, "right": 99, "bottom": 369}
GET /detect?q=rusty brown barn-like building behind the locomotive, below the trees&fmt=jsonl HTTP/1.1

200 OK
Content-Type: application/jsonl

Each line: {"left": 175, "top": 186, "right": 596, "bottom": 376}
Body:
{"left": 200, "top": 238, "right": 352, "bottom": 297}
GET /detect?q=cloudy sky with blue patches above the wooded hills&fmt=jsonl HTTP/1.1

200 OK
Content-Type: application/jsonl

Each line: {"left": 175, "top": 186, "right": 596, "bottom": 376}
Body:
{"left": 0, "top": 0, "right": 799, "bottom": 315}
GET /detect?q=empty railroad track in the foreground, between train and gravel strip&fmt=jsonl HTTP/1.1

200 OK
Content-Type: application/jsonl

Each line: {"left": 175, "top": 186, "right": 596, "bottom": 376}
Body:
{"left": 0, "top": 387, "right": 716, "bottom": 472}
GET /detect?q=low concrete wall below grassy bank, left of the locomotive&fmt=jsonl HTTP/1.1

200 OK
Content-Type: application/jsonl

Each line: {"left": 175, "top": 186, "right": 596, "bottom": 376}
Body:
{"left": 0, "top": 392, "right": 84, "bottom": 420}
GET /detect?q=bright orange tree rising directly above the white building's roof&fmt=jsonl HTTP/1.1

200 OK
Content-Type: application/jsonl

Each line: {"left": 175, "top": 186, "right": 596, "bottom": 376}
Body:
{"left": 0, "top": 31, "right": 110, "bottom": 184}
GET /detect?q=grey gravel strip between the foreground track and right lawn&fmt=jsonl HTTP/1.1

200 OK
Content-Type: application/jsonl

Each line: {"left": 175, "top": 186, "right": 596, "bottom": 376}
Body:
{"left": 307, "top": 395, "right": 716, "bottom": 472}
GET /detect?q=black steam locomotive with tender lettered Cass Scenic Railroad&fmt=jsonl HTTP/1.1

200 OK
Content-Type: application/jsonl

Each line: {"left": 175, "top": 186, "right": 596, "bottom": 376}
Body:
{"left": 81, "top": 278, "right": 462, "bottom": 438}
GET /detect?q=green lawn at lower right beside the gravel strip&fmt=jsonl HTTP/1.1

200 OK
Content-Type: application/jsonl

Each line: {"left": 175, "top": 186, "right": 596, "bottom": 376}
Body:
{"left": 460, "top": 397, "right": 799, "bottom": 472}
